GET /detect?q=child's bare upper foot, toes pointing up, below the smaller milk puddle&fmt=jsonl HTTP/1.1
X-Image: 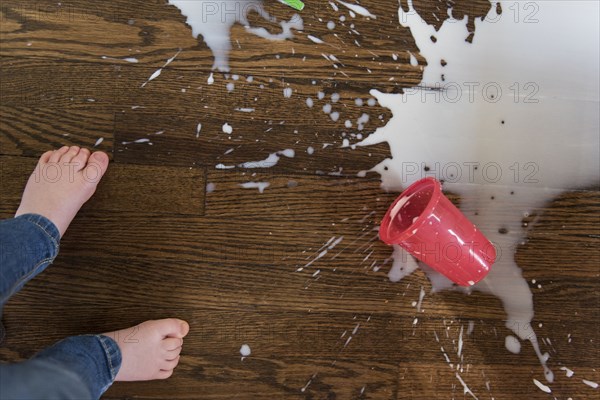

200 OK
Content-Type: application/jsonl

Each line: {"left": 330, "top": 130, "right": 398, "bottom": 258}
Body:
{"left": 15, "top": 146, "right": 108, "bottom": 237}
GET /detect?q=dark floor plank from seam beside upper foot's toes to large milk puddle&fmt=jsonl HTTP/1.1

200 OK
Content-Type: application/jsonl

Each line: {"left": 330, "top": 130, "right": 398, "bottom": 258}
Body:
{"left": 115, "top": 109, "right": 389, "bottom": 175}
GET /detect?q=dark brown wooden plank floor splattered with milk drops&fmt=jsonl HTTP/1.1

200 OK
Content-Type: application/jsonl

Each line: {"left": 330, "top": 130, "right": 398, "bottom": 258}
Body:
{"left": 0, "top": 0, "right": 600, "bottom": 399}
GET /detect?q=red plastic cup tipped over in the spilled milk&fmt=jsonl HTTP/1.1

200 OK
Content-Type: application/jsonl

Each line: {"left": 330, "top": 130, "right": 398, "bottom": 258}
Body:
{"left": 379, "top": 178, "right": 496, "bottom": 286}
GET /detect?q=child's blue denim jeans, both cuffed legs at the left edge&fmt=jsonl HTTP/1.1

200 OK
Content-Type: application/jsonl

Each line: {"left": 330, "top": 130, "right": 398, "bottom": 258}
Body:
{"left": 0, "top": 214, "right": 121, "bottom": 400}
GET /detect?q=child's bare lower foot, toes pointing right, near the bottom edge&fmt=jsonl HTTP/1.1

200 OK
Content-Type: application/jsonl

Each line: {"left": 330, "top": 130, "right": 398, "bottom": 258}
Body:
{"left": 104, "top": 318, "right": 190, "bottom": 381}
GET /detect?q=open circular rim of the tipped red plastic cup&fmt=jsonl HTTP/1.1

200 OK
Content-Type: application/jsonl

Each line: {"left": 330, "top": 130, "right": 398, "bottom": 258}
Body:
{"left": 379, "top": 177, "right": 442, "bottom": 245}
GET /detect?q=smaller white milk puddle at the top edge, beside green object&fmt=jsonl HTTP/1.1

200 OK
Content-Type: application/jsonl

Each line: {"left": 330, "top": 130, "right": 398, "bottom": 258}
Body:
{"left": 169, "top": 0, "right": 304, "bottom": 71}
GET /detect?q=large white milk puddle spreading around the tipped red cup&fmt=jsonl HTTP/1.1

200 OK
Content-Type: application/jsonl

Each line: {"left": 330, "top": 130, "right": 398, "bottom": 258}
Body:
{"left": 358, "top": 1, "right": 600, "bottom": 382}
